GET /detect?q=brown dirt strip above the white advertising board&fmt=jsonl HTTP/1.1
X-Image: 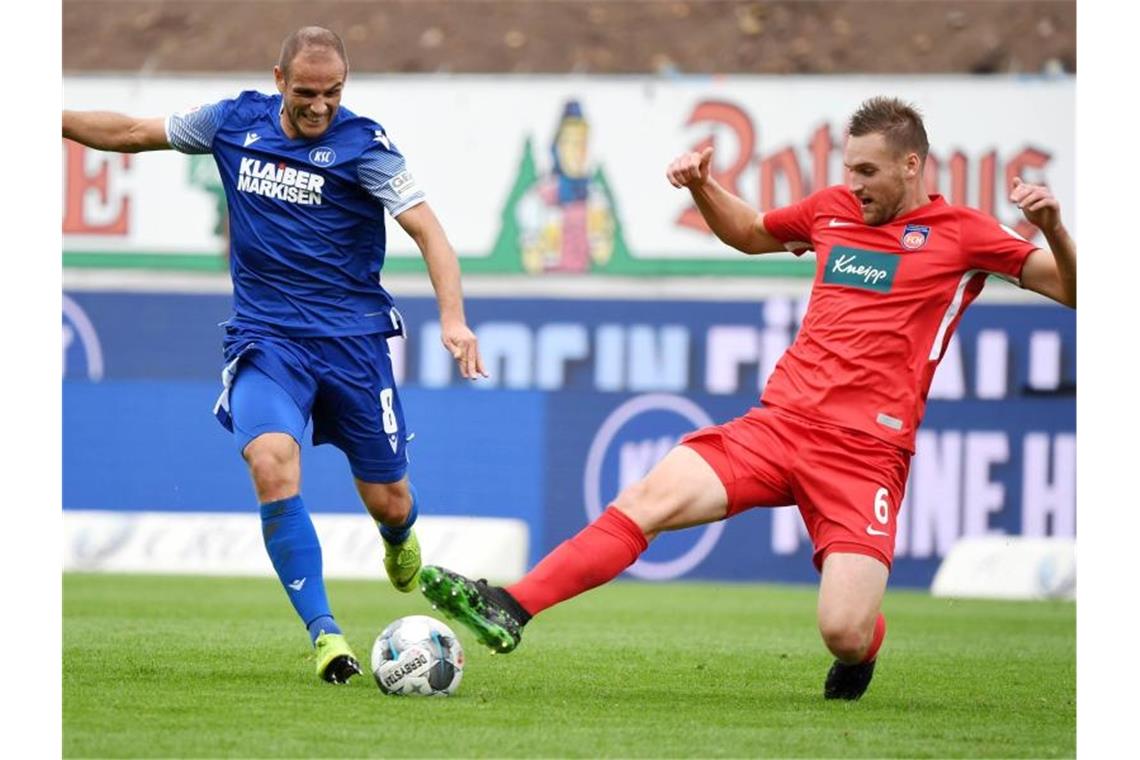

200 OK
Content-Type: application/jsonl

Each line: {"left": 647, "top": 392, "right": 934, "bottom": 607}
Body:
{"left": 63, "top": 0, "right": 1076, "bottom": 74}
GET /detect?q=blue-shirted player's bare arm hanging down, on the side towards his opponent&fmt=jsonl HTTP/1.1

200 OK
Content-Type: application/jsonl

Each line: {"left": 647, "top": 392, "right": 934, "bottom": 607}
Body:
{"left": 396, "top": 202, "right": 488, "bottom": 379}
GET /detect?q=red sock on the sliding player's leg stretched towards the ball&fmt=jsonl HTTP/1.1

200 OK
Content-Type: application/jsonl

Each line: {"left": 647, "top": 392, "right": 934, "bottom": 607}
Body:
{"left": 506, "top": 507, "right": 649, "bottom": 615}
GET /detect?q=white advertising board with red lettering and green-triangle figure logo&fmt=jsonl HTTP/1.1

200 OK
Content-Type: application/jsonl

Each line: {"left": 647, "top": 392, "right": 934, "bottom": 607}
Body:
{"left": 64, "top": 71, "right": 1076, "bottom": 273}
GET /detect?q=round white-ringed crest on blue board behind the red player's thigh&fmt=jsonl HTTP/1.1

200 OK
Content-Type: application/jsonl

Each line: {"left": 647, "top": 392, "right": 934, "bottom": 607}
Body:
{"left": 583, "top": 393, "right": 724, "bottom": 580}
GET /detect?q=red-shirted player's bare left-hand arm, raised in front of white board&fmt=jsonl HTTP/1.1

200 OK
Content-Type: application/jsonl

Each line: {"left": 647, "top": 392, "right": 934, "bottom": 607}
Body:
{"left": 665, "top": 147, "right": 784, "bottom": 253}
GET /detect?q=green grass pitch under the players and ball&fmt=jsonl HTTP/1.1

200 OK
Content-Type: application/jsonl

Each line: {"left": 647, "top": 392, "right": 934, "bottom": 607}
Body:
{"left": 63, "top": 574, "right": 1076, "bottom": 758}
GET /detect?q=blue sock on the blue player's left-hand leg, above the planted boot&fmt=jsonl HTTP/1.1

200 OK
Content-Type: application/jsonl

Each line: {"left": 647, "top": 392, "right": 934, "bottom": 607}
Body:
{"left": 261, "top": 493, "right": 341, "bottom": 640}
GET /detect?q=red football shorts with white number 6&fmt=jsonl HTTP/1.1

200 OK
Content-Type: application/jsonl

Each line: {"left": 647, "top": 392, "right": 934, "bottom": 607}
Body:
{"left": 681, "top": 407, "right": 911, "bottom": 570}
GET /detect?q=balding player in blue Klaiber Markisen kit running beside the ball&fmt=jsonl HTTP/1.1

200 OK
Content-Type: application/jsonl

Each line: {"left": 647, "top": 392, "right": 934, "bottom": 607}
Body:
{"left": 63, "top": 26, "right": 487, "bottom": 684}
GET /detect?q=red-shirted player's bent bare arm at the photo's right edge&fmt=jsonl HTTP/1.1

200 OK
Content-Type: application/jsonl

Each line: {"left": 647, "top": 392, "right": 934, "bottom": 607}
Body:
{"left": 1009, "top": 177, "right": 1076, "bottom": 309}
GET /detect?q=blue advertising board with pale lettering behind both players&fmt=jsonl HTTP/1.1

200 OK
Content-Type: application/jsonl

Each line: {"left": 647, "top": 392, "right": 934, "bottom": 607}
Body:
{"left": 64, "top": 292, "right": 1076, "bottom": 586}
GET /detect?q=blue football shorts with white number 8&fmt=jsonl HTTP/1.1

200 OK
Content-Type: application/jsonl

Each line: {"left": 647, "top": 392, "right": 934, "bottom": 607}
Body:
{"left": 214, "top": 327, "right": 408, "bottom": 483}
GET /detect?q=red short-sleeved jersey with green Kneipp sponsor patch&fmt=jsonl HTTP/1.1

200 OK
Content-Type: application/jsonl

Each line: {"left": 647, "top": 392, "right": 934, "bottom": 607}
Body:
{"left": 762, "top": 186, "right": 1037, "bottom": 452}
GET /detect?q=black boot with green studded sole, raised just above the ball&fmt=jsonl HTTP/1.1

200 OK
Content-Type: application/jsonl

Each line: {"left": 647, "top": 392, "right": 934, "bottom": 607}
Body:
{"left": 420, "top": 565, "right": 530, "bottom": 654}
